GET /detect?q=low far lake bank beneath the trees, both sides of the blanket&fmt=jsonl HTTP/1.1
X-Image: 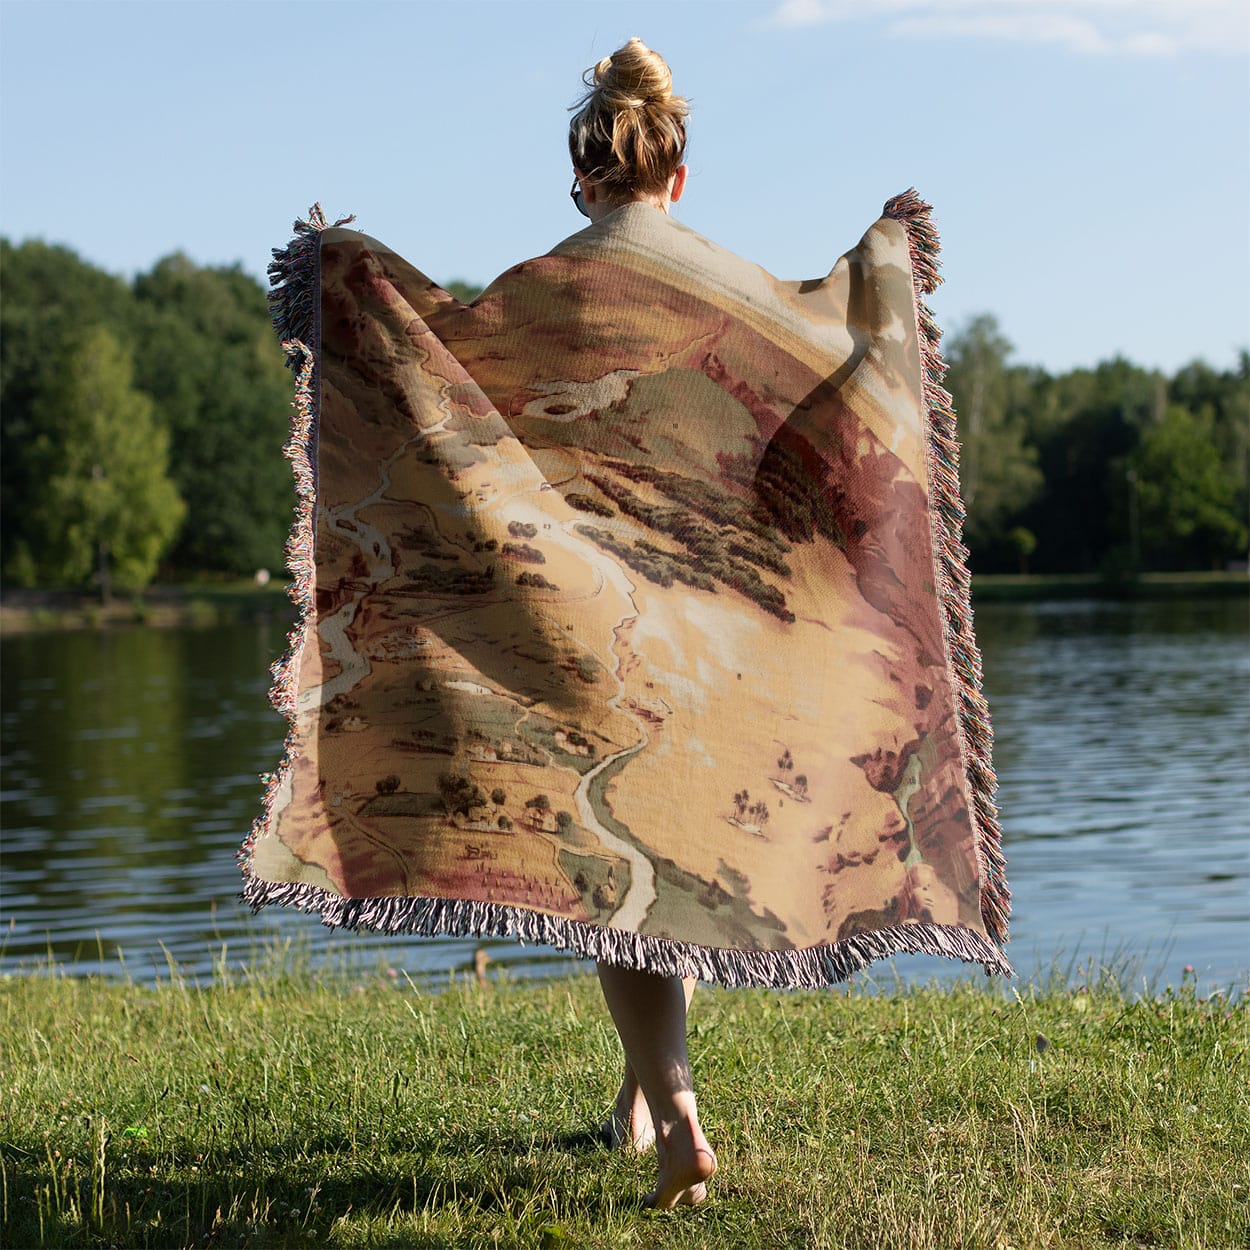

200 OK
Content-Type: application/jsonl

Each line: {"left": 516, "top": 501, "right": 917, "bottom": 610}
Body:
{"left": 0, "top": 573, "right": 1250, "bottom": 635}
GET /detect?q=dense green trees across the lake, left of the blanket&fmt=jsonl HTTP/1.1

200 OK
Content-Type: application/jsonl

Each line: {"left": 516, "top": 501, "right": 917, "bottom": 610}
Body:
{"left": 0, "top": 240, "right": 294, "bottom": 600}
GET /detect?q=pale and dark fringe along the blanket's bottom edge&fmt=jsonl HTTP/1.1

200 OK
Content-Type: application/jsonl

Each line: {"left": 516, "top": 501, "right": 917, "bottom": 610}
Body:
{"left": 244, "top": 876, "right": 1013, "bottom": 989}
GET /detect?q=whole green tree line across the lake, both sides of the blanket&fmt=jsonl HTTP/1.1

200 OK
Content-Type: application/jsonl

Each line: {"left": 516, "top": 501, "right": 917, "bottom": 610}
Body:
{"left": 0, "top": 239, "right": 1250, "bottom": 594}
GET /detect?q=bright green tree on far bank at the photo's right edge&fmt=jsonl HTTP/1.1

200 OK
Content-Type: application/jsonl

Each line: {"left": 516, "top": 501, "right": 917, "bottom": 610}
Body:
{"left": 1129, "top": 404, "right": 1246, "bottom": 569}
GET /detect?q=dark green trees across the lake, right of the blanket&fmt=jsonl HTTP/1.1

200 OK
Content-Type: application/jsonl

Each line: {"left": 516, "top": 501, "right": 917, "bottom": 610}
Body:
{"left": 944, "top": 315, "right": 1250, "bottom": 574}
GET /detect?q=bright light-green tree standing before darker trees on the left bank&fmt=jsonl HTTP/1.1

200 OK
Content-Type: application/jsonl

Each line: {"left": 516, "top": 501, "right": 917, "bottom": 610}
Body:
{"left": 28, "top": 326, "right": 185, "bottom": 599}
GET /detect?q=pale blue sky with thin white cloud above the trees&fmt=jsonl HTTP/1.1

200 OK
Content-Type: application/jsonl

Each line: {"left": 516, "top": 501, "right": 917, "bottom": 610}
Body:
{"left": 0, "top": 0, "right": 1250, "bottom": 370}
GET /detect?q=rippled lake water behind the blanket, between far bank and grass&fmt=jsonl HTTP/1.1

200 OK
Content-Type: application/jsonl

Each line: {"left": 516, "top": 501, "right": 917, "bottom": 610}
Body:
{"left": 0, "top": 600, "right": 1250, "bottom": 986}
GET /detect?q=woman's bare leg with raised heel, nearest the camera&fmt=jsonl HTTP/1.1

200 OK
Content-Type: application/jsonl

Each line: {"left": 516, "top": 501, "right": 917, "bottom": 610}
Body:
{"left": 599, "top": 964, "right": 716, "bottom": 1208}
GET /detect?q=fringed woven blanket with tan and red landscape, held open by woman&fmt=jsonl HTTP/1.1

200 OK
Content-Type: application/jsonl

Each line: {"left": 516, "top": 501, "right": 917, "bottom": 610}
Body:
{"left": 240, "top": 191, "right": 1011, "bottom": 986}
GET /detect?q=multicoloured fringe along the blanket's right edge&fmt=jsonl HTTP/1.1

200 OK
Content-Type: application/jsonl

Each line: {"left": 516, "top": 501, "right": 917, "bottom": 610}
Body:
{"left": 881, "top": 188, "right": 1011, "bottom": 944}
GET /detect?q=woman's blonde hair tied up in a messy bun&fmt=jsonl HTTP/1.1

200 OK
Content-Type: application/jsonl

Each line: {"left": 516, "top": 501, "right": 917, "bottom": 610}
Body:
{"left": 569, "top": 38, "right": 690, "bottom": 195}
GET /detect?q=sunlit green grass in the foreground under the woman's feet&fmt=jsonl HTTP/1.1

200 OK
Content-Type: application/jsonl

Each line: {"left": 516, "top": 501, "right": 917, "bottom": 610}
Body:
{"left": 0, "top": 968, "right": 1250, "bottom": 1250}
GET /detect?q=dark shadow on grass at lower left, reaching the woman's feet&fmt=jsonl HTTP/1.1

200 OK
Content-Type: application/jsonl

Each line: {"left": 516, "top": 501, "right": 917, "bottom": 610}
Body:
{"left": 0, "top": 1129, "right": 643, "bottom": 1248}
